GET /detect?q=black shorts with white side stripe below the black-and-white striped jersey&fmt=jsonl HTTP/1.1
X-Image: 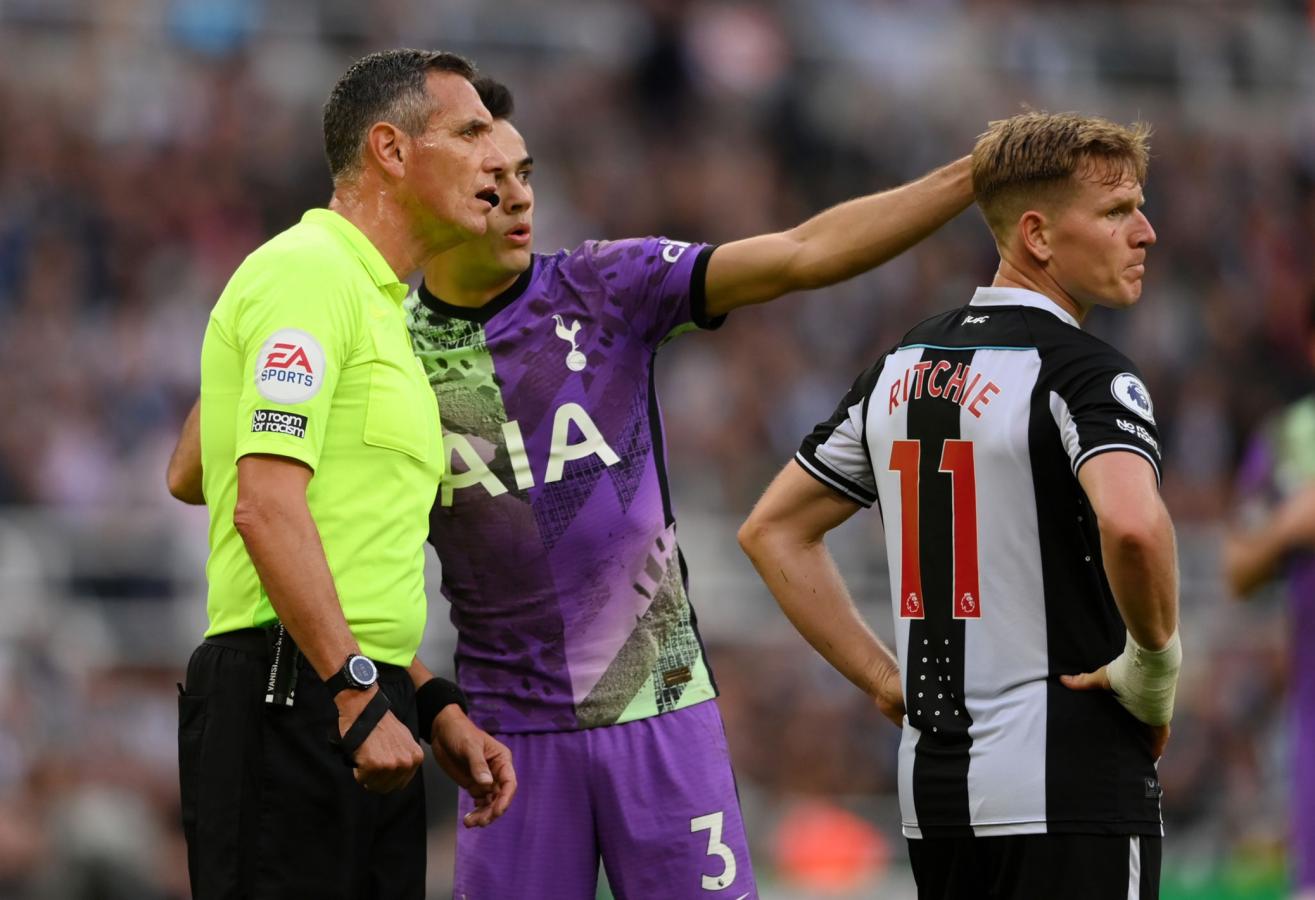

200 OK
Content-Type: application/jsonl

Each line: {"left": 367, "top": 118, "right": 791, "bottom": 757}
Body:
{"left": 909, "top": 834, "right": 1160, "bottom": 900}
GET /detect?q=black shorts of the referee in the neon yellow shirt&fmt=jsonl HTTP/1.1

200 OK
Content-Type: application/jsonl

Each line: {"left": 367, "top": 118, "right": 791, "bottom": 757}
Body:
{"left": 178, "top": 629, "right": 426, "bottom": 900}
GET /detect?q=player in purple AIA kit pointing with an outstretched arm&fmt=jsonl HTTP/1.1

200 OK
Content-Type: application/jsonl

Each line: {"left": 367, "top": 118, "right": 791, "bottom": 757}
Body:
{"left": 408, "top": 80, "right": 972, "bottom": 900}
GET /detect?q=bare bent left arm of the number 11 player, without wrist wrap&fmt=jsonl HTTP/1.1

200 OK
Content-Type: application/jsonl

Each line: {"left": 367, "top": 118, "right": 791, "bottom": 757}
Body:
{"left": 739, "top": 461, "right": 905, "bottom": 725}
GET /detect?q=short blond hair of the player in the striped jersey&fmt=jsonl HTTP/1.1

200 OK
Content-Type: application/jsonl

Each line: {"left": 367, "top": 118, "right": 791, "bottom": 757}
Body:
{"left": 973, "top": 112, "right": 1151, "bottom": 243}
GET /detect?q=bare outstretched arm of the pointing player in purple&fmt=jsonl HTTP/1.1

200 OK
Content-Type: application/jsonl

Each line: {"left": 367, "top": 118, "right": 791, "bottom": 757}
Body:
{"left": 706, "top": 157, "right": 973, "bottom": 317}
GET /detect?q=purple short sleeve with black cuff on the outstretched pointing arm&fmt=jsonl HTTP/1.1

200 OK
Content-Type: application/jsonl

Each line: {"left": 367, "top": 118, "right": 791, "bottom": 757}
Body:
{"left": 581, "top": 237, "right": 726, "bottom": 347}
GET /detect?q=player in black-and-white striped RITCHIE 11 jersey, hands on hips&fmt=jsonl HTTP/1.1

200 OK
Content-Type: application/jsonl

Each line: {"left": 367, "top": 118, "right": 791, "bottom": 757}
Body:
{"left": 740, "top": 113, "right": 1182, "bottom": 900}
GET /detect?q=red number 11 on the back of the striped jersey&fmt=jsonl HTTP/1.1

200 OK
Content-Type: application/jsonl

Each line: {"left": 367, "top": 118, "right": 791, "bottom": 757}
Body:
{"left": 890, "top": 438, "right": 982, "bottom": 618}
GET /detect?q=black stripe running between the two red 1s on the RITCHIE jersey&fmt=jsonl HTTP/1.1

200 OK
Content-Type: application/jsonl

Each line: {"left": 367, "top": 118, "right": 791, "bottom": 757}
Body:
{"left": 904, "top": 347, "right": 974, "bottom": 837}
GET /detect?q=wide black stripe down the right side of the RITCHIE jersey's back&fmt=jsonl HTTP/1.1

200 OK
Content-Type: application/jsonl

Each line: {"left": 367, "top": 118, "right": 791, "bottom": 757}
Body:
{"left": 1028, "top": 350, "right": 1161, "bottom": 836}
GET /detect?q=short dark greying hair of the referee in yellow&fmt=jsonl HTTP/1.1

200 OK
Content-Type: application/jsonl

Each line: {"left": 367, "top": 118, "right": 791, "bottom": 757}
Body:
{"left": 325, "top": 50, "right": 475, "bottom": 182}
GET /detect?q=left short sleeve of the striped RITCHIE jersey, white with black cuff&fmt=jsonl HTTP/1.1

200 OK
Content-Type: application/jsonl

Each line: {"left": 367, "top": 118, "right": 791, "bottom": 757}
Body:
{"left": 794, "top": 359, "right": 885, "bottom": 507}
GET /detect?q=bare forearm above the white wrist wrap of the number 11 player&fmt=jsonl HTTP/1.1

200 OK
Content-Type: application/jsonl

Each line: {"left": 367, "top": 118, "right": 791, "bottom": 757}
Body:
{"left": 1101, "top": 508, "right": 1178, "bottom": 650}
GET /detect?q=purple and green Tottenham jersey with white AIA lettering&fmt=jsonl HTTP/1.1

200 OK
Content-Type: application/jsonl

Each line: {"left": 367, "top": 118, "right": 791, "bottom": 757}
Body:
{"left": 408, "top": 238, "right": 717, "bottom": 733}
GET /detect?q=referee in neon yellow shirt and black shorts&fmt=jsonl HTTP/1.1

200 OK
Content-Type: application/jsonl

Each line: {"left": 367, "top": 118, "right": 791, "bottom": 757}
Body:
{"left": 179, "top": 50, "right": 514, "bottom": 900}
